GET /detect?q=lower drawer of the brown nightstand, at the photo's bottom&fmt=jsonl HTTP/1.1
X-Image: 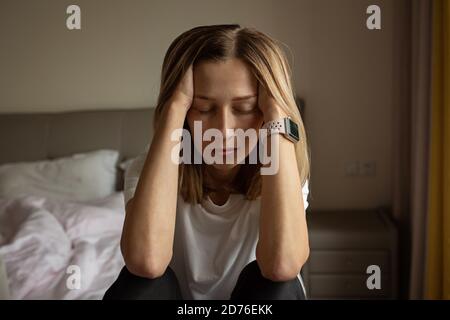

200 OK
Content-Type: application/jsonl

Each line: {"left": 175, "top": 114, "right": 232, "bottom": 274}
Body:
{"left": 309, "top": 275, "right": 391, "bottom": 299}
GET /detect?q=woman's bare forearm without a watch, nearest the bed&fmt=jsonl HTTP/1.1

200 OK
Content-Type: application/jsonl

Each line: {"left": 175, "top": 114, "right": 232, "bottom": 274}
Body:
{"left": 121, "top": 105, "right": 185, "bottom": 276}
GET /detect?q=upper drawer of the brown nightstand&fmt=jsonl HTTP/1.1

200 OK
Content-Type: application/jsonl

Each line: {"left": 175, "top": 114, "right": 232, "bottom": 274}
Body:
{"left": 308, "top": 250, "right": 391, "bottom": 275}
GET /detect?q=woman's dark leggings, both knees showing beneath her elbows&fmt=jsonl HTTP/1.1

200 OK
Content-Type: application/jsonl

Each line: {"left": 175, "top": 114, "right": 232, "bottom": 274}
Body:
{"left": 103, "top": 260, "right": 306, "bottom": 300}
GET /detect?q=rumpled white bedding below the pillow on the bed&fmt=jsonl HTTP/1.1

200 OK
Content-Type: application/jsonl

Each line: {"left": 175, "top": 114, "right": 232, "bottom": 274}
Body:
{"left": 0, "top": 192, "right": 125, "bottom": 299}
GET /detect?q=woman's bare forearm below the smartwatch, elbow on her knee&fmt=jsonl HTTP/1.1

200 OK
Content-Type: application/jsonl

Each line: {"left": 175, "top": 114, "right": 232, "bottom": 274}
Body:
{"left": 256, "top": 113, "right": 309, "bottom": 280}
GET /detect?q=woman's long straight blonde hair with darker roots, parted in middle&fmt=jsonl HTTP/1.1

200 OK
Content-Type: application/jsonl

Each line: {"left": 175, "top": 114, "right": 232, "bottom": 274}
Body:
{"left": 153, "top": 24, "right": 310, "bottom": 204}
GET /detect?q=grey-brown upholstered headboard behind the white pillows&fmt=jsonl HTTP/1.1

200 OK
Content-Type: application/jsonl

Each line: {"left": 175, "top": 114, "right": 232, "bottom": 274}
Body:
{"left": 0, "top": 108, "right": 154, "bottom": 189}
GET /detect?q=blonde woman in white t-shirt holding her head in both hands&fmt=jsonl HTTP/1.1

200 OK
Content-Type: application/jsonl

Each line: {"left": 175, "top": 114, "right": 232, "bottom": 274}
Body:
{"left": 105, "top": 25, "right": 309, "bottom": 299}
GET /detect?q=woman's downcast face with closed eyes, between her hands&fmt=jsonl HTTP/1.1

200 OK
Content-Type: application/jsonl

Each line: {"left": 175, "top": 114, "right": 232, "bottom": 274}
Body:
{"left": 186, "top": 59, "right": 263, "bottom": 170}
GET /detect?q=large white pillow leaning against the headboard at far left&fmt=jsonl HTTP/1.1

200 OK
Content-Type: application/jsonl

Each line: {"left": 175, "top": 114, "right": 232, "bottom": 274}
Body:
{"left": 0, "top": 150, "right": 119, "bottom": 201}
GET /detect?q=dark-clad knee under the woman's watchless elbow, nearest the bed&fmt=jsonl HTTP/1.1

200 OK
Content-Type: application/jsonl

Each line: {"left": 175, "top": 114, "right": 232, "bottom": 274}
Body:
{"left": 103, "top": 266, "right": 181, "bottom": 300}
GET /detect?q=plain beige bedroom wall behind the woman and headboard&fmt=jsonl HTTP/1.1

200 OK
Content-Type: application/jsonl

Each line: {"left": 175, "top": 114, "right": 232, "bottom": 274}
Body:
{"left": 0, "top": 0, "right": 408, "bottom": 208}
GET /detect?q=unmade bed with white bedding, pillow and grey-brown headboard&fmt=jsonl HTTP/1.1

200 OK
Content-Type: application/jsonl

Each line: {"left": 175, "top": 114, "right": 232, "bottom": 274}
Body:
{"left": 0, "top": 108, "right": 153, "bottom": 299}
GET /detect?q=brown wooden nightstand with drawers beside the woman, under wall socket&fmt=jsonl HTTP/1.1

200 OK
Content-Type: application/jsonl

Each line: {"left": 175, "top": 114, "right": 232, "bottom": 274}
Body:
{"left": 302, "top": 209, "right": 398, "bottom": 299}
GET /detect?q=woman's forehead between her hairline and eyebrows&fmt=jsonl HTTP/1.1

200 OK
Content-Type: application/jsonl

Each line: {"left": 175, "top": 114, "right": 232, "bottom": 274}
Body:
{"left": 194, "top": 58, "right": 257, "bottom": 98}
